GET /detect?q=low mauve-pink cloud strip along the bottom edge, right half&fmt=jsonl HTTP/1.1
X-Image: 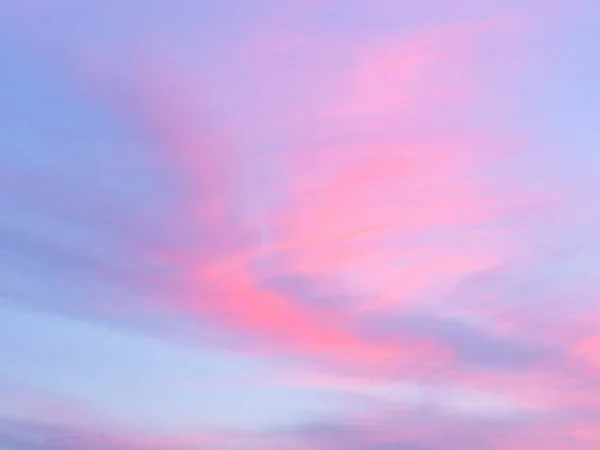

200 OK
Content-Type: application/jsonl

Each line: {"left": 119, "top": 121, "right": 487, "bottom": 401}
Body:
{"left": 288, "top": 398, "right": 597, "bottom": 450}
